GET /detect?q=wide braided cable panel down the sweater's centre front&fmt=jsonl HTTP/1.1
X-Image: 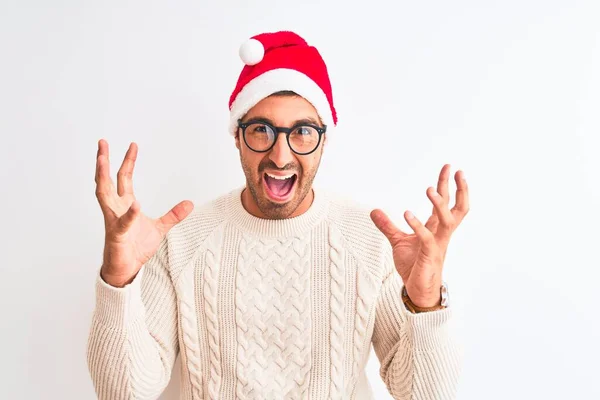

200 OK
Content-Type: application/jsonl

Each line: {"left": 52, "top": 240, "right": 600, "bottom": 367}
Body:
{"left": 235, "top": 234, "right": 311, "bottom": 399}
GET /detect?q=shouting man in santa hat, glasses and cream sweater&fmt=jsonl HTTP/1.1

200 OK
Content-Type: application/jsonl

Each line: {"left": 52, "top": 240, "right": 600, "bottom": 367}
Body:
{"left": 88, "top": 32, "right": 468, "bottom": 399}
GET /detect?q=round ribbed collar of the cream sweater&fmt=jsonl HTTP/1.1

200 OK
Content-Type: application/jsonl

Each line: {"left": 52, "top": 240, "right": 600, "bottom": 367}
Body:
{"left": 227, "top": 186, "right": 329, "bottom": 237}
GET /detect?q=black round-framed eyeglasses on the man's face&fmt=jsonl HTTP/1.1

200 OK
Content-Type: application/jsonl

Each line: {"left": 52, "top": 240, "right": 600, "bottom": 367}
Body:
{"left": 238, "top": 119, "right": 327, "bottom": 156}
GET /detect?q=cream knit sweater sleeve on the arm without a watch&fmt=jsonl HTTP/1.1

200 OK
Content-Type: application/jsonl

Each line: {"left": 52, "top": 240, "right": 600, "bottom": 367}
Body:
{"left": 87, "top": 239, "right": 179, "bottom": 400}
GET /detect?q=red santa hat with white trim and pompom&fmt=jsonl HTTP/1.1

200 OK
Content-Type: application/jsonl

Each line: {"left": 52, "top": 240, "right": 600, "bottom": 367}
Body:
{"left": 229, "top": 31, "right": 337, "bottom": 135}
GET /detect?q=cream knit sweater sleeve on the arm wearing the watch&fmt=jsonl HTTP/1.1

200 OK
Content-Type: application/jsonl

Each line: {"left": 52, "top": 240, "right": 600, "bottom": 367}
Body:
{"left": 373, "top": 255, "right": 462, "bottom": 400}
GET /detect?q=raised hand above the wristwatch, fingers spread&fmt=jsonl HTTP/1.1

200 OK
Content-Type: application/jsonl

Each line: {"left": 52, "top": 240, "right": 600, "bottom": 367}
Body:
{"left": 371, "top": 164, "right": 469, "bottom": 307}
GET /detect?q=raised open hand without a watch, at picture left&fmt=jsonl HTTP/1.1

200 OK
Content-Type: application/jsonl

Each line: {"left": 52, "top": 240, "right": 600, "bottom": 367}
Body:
{"left": 95, "top": 139, "right": 194, "bottom": 287}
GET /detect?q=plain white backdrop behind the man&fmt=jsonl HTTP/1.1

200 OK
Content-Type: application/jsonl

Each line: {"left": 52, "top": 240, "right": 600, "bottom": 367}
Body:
{"left": 0, "top": 0, "right": 600, "bottom": 400}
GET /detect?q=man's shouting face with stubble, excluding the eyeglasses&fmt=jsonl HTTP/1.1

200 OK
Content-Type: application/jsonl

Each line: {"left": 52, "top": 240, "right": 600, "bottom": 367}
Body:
{"left": 235, "top": 95, "right": 325, "bottom": 219}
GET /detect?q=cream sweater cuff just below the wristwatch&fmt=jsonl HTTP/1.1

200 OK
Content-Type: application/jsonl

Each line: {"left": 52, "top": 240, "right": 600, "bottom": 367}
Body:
{"left": 406, "top": 308, "right": 452, "bottom": 351}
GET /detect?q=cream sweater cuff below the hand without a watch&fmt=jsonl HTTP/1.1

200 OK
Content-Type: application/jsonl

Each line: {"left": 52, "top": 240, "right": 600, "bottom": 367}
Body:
{"left": 95, "top": 266, "right": 145, "bottom": 329}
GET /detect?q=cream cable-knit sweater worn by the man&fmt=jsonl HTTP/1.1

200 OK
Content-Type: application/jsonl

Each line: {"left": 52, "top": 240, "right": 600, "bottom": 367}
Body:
{"left": 87, "top": 188, "right": 462, "bottom": 400}
